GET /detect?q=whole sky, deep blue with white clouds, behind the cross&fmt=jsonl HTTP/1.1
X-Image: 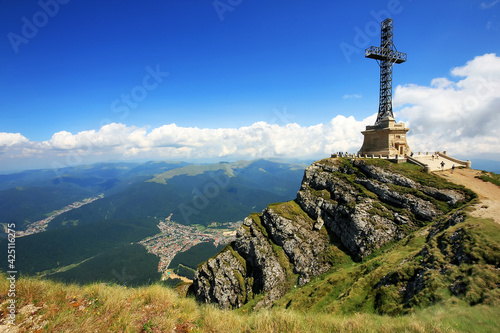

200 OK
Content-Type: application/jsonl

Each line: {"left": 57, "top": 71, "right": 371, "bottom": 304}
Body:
{"left": 0, "top": 0, "right": 500, "bottom": 170}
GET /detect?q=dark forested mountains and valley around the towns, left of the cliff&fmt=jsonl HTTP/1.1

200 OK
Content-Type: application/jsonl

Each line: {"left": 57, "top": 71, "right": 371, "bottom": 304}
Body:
{"left": 0, "top": 160, "right": 307, "bottom": 284}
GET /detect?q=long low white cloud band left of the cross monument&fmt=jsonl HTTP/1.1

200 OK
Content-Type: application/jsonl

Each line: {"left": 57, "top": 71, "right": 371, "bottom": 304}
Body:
{"left": 0, "top": 116, "right": 373, "bottom": 167}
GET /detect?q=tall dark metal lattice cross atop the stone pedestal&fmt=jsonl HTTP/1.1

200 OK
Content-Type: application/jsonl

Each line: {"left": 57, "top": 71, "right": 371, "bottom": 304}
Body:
{"left": 365, "top": 18, "right": 406, "bottom": 125}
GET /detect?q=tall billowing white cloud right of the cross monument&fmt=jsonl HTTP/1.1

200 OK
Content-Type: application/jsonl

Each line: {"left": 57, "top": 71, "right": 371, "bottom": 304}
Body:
{"left": 393, "top": 54, "right": 500, "bottom": 158}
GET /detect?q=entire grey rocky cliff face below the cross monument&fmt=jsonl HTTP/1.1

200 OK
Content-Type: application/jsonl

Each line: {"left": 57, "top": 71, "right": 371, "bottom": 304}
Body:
{"left": 192, "top": 158, "right": 465, "bottom": 308}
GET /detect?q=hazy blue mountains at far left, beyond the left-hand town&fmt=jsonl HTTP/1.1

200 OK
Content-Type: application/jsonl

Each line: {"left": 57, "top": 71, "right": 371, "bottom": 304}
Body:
{"left": 0, "top": 162, "right": 187, "bottom": 230}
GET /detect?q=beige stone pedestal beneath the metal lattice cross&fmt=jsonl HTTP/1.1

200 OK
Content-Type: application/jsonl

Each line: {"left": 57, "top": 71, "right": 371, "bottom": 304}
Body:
{"left": 358, "top": 117, "right": 411, "bottom": 157}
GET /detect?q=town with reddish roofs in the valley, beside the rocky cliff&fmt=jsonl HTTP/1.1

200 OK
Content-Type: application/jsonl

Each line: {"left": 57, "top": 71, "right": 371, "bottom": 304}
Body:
{"left": 139, "top": 215, "right": 242, "bottom": 273}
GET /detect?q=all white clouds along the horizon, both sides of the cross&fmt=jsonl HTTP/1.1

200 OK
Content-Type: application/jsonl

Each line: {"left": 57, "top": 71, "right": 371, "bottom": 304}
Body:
{"left": 0, "top": 54, "right": 500, "bottom": 169}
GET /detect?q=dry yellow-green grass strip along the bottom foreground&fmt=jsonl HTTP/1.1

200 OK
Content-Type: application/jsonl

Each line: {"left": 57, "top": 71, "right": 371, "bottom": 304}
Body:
{"left": 0, "top": 268, "right": 500, "bottom": 333}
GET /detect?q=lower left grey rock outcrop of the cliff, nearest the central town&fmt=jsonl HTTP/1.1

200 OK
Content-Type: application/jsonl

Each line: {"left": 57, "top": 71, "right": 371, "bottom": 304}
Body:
{"left": 192, "top": 202, "right": 330, "bottom": 309}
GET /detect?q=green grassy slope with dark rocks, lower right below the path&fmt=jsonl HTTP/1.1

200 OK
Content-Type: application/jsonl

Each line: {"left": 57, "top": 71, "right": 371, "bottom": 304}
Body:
{"left": 274, "top": 215, "right": 500, "bottom": 315}
